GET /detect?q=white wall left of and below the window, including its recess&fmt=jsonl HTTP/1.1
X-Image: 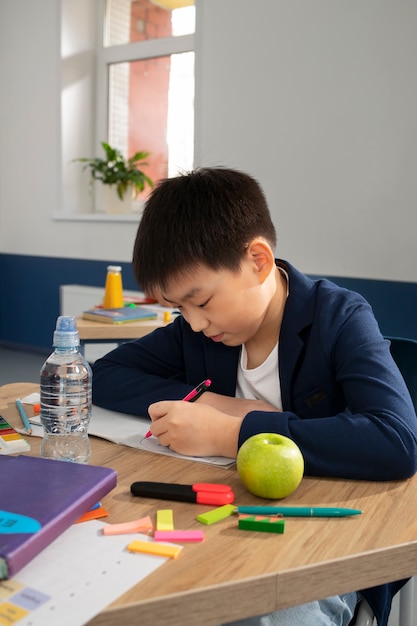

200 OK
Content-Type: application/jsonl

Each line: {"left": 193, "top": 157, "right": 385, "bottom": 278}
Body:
{"left": 0, "top": 0, "right": 137, "bottom": 261}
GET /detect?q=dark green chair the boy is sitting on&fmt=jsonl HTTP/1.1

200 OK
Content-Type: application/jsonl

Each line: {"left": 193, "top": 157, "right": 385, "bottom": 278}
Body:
{"left": 354, "top": 337, "right": 417, "bottom": 626}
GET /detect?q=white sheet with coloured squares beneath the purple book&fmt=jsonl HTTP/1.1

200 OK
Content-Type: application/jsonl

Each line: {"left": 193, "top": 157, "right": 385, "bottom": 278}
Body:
{"left": 0, "top": 520, "right": 171, "bottom": 626}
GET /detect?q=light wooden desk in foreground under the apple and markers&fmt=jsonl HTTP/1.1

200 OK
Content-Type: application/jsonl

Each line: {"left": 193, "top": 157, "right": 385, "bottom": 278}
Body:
{"left": 0, "top": 383, "right": 417, "bottom": 626}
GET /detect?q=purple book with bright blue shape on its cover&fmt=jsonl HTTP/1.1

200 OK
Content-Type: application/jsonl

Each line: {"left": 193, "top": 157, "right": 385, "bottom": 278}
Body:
{"left": 0, "top": 455, "right": 117, "bottom": 580}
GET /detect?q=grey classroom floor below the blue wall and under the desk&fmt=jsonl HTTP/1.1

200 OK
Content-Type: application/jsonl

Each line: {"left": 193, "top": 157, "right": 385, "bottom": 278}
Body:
{"left": 0, "top": 347, "right": 417, "bottom": 626}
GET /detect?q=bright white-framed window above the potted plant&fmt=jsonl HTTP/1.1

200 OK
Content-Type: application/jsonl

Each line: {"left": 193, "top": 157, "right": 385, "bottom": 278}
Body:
{"left": 96, "top": 0, "right": 195, "bottom": 201}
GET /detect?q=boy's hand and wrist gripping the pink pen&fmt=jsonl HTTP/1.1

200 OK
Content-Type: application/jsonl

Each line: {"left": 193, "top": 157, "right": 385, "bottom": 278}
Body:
{"left": 148, "top": 394, "right": 243, "bottom": 458}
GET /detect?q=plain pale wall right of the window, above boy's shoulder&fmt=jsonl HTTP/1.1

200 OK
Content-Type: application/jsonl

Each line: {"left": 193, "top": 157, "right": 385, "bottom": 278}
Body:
{"left": 193, "top": 0, "right": 417, "bottom": 281}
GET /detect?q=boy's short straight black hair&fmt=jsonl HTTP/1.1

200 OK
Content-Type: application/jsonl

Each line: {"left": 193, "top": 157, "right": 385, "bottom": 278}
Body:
{"left": 132, "top": 167, "right": 276, "bottom": 293}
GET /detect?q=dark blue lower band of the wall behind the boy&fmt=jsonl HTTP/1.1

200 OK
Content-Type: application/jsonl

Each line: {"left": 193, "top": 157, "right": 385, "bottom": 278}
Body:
{"left": 0, "top": 254, "right": 417, "bottom": 352}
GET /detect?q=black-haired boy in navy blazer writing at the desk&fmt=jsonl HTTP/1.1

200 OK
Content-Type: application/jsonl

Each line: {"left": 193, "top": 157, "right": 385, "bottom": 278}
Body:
{"left": 93, "top": 168, "right": 417, "bottom": 626}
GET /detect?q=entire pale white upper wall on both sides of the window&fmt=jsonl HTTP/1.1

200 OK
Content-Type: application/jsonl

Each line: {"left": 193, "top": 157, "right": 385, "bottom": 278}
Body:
{"left": 0, "top": 0, "right": 417, "bottom": 281}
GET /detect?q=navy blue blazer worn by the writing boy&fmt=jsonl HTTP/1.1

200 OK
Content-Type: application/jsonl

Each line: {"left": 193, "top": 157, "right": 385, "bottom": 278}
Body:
{"left": 93, "top": 260, "right": 417, "bottom": 626}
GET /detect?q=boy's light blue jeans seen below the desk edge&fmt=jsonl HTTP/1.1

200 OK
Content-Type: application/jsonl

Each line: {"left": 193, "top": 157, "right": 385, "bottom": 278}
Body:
{"left": 224, "top": 592, "right": 359, "bottom": 626}
